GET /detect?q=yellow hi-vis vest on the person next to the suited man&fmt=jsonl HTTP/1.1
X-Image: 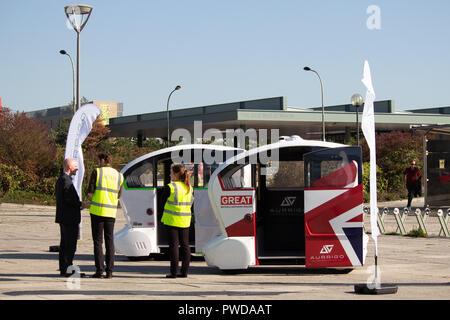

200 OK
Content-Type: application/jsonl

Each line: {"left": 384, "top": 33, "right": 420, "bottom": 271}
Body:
{"left": 89, "top": 167, "right": 123, "bottom": 218}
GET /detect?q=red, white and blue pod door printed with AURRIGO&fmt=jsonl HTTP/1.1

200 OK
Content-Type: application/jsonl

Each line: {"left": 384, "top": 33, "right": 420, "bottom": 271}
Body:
{"left": 304, "top": 147, "right": 364, "bottom": 267}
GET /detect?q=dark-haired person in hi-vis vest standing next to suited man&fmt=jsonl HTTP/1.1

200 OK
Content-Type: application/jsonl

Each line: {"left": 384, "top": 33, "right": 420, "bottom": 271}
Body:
{"left": 88, "top": 153, "right": 123, "bottom": 278}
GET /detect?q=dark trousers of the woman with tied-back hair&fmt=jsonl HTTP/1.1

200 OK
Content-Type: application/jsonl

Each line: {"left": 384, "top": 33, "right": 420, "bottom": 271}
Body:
{"left": 166, "top": 225, "right": 191, "bottom": 275}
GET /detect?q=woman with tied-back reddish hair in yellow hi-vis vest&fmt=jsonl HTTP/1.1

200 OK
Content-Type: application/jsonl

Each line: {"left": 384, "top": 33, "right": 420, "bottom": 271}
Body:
{"left": 161, "top": 164, "right": 194, "bottom": 278}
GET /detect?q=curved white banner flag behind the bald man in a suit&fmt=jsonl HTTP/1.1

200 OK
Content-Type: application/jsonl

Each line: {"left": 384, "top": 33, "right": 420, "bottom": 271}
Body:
{"left": 64, "top": 104, "right": 102, "bottom": 201}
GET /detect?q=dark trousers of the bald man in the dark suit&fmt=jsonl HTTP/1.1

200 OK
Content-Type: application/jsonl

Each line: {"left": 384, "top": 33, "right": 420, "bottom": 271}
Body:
{"left": 59, "top": 223, "right": 79, "bottom": 274}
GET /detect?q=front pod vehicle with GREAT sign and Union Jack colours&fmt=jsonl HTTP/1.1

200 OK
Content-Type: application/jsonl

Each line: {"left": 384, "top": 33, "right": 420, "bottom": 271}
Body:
{"left": 203, "top": 136, "right": 367, "bottom": 270}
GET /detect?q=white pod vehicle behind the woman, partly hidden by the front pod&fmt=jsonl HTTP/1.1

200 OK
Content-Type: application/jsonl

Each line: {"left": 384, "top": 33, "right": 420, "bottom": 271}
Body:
{"left": 114, "top": 144, "right": 244, "bottom": 259}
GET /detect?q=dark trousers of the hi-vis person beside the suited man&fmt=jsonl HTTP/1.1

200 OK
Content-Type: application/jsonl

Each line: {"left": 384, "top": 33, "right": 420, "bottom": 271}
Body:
{"left": 91, "top": 214, "right": 116, "bottom": 273}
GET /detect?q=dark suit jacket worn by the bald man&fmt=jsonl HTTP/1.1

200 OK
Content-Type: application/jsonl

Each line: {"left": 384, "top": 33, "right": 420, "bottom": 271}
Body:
{"left": 55, "top": 173, "right": 81, "bottom": 224}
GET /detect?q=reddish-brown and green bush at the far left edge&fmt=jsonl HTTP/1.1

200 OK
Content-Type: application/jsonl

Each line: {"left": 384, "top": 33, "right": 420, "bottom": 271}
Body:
{"left": 0, "top": 109, "right": 58, "bottom": 202}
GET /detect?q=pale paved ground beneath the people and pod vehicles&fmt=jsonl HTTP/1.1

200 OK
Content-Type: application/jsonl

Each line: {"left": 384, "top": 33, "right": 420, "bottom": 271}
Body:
{"left": 0, "top": 203, "right": 450, "bottom": 301}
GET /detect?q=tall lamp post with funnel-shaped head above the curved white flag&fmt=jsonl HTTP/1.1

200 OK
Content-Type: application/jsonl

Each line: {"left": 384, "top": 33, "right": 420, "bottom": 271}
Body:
{"left": 64, "top": 4, "right": 93, "bottom": 110}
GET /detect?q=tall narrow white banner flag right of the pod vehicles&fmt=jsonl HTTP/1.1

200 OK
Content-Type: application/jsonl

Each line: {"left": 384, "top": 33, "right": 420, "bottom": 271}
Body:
{"left": 361, "top": 61, "right": 380, "bottom": 256}
